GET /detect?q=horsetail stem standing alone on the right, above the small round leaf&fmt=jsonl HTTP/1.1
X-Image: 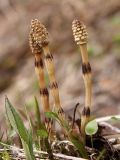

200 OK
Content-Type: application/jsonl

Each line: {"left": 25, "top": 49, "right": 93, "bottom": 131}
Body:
{"left": 72, "top": 20, "right": 92, "bottom": 137}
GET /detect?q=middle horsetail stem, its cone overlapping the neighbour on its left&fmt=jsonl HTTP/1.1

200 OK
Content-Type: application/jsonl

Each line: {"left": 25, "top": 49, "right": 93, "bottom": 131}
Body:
{"left": 30, "top": 20, "right": 63, "bottom": 115}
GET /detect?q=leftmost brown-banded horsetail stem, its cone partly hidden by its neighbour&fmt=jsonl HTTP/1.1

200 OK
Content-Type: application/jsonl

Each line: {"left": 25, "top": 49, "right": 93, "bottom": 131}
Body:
{"left": 29, "top": 25, "right": 52, "bottom": 130}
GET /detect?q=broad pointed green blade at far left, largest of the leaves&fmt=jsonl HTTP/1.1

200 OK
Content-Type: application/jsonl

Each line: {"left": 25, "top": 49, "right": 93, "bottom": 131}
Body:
{"left": 5, "top": 98, "right": 35, "bottom": 160}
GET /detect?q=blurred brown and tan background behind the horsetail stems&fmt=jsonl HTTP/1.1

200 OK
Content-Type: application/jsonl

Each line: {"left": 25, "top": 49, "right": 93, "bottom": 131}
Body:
{"left": 0, "top": 0, "right": 120, "bottom": 122}
